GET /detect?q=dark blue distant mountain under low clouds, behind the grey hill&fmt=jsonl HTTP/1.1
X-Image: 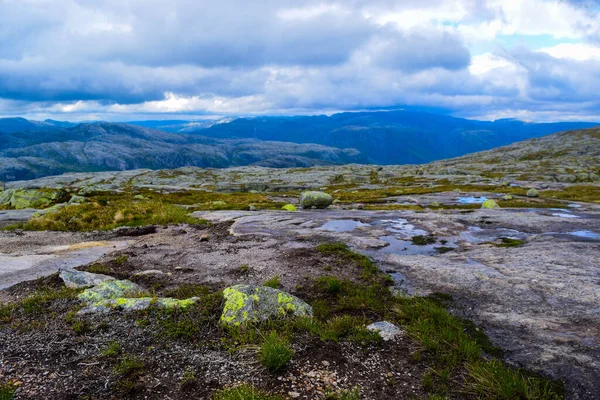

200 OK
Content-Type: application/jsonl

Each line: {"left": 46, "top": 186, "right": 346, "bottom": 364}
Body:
{"left": 180, "top": 111, "right": 597, "bottom": 165}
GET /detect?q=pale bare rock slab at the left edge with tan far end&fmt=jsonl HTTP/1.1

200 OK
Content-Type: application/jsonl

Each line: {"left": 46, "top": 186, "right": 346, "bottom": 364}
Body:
{"left": 0, "top": 241, "right": 129, "bottom": 289}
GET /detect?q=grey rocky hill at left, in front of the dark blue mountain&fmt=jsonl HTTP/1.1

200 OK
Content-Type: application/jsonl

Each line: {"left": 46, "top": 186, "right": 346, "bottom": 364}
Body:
{"left": 0, "top": 119, "right": 365, "bottom": 181}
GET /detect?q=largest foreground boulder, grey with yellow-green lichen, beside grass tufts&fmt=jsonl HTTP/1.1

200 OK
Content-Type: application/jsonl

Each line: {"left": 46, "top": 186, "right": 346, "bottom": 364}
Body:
{"left": 221, "top": 285, "right": 312, "bottom": 325}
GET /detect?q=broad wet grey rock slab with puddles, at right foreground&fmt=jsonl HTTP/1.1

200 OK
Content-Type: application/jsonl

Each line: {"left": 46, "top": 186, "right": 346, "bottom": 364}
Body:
{"left": 197, "top": 205, "right": 600, "bottom": 399}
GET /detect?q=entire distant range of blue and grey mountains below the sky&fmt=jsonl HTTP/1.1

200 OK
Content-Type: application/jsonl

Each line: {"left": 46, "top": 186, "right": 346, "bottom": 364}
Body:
{"left": 0, "top": 111, "right": 597, "bottom": 180}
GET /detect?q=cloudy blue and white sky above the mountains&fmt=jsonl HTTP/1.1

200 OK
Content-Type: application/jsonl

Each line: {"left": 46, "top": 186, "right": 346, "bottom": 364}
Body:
{"left": 0, "top": 0, "right": 600, "bottom": 121}
